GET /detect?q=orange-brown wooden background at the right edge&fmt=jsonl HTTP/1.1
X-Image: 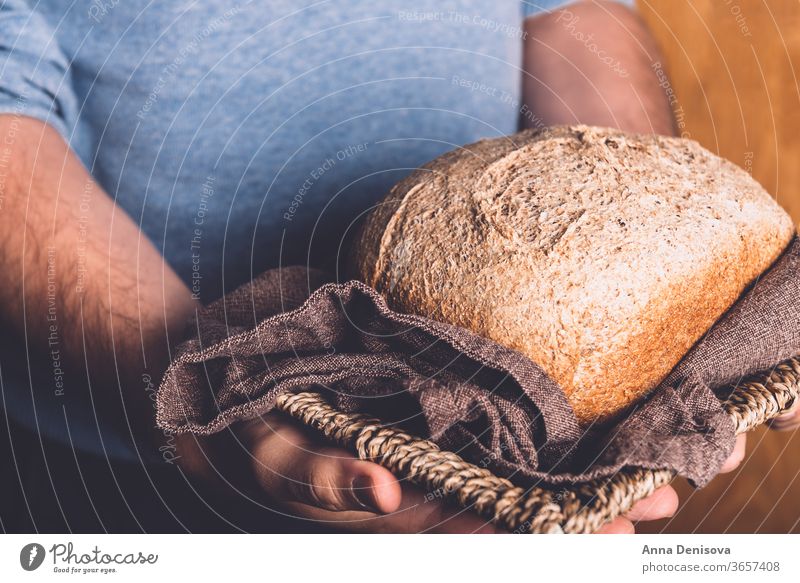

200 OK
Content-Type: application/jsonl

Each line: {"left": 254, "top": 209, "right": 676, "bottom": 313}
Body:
{"left": 639, "top": 0, "right": 800, "bottom": 532}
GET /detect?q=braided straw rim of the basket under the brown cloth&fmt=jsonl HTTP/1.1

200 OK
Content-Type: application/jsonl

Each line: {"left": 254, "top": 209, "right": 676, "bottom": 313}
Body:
{"left": 276, "top": 356, "right": 800, "bottom": 533}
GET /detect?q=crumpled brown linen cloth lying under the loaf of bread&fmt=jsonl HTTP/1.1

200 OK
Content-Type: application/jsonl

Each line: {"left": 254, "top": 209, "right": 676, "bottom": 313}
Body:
{"left": 157, "top": 238, "right": 800, "bottom": 486}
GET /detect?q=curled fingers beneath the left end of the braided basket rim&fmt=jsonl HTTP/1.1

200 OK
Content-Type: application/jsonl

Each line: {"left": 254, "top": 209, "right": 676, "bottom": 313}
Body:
{"left": 245, "top": 416, "right": 401, "bottom": 513}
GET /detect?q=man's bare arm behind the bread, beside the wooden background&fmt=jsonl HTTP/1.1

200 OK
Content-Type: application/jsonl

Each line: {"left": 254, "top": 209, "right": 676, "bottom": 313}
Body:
{"left": 522, "top": 2, "right": 675, "bottom": 135}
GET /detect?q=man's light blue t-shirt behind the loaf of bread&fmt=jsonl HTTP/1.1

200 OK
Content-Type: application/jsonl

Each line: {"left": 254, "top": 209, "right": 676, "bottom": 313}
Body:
{"left": 0, "top": 0, "right": 632, "bottom": 460}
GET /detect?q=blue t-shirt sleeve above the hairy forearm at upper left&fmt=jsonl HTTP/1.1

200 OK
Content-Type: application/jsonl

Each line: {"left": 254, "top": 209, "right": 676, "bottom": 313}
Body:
{"left": 0, "top": 0, "right": 78, "bottom": 141}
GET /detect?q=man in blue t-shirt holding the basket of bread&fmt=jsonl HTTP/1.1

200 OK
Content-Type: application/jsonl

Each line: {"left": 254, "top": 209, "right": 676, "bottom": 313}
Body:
{"left": 0, "top": 0, "right": 780, "bottom": 532}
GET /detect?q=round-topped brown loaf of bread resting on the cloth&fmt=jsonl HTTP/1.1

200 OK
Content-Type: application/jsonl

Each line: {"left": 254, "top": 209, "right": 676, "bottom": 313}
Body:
{"left": 352, "top": 126, "right": 794, "bottom": 423}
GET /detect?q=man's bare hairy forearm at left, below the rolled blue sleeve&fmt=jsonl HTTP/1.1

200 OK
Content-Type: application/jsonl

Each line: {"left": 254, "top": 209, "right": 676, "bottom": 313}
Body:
{"left": 0, "top": 116, "right": 194, "bottom": 448}
